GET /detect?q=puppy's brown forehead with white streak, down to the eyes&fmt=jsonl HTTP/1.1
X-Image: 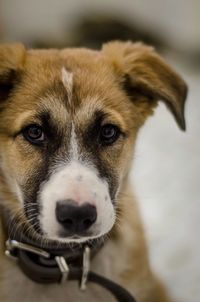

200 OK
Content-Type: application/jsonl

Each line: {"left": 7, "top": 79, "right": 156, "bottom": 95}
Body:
{"left": 0, "top": 50, "right": 134, "bottom": 135}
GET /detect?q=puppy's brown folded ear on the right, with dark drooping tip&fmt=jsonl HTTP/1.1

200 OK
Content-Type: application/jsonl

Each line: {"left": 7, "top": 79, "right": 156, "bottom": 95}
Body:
{"left": 103, "top": 42, "right": 187, "bottom": 130}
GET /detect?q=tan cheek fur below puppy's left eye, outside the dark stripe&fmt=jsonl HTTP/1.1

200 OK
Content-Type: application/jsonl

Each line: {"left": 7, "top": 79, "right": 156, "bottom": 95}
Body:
{"left": 3, "top": 140, "right": 48, "bottom": 225}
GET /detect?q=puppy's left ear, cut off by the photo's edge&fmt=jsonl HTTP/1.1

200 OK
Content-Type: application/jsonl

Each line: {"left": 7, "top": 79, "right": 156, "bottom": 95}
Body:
{"left": 0, "top": 43, "right": 26, "bottom": 101}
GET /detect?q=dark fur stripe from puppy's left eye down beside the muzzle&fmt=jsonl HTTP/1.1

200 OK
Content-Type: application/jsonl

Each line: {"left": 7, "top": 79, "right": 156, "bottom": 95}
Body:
{"left": 22, "top": 111, "right": 68, "bottom": 233}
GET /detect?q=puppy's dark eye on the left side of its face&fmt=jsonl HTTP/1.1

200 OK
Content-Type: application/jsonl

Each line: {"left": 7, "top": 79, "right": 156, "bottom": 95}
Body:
{"left": 22, "top": 125, "right": 45, "bottom": 144}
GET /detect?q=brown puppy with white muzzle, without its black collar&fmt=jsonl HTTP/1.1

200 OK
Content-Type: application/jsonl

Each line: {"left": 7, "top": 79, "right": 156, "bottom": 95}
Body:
{"left": 0, "top": 41, "right": 187, "bottom": 302}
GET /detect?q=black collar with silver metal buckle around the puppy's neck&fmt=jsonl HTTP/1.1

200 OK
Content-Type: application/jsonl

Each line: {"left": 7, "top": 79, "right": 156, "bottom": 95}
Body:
{"left": 2, "top": 209, "right": 136, "bottom": 302}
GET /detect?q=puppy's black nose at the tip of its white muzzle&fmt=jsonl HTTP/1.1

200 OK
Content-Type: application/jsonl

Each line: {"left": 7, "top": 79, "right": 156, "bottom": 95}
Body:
{"left": 56, "top": 199, "right": 97, "bottom": 236}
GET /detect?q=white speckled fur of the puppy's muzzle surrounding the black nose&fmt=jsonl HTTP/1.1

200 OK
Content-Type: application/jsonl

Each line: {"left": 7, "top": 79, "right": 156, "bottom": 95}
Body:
{"left": 40, "top": 161, "right": 115, "bottom": 242}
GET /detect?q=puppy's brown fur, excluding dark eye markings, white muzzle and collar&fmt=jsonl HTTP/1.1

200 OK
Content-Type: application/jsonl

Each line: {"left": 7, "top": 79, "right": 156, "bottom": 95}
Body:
{"left": 0, "top": 42, "right": 187, "bottom": 302}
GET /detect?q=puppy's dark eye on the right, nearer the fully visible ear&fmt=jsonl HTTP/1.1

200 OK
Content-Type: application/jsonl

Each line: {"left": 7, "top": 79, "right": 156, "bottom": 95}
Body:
{"left": 99, "top": 124, "right": 120, "bottom": 145}
